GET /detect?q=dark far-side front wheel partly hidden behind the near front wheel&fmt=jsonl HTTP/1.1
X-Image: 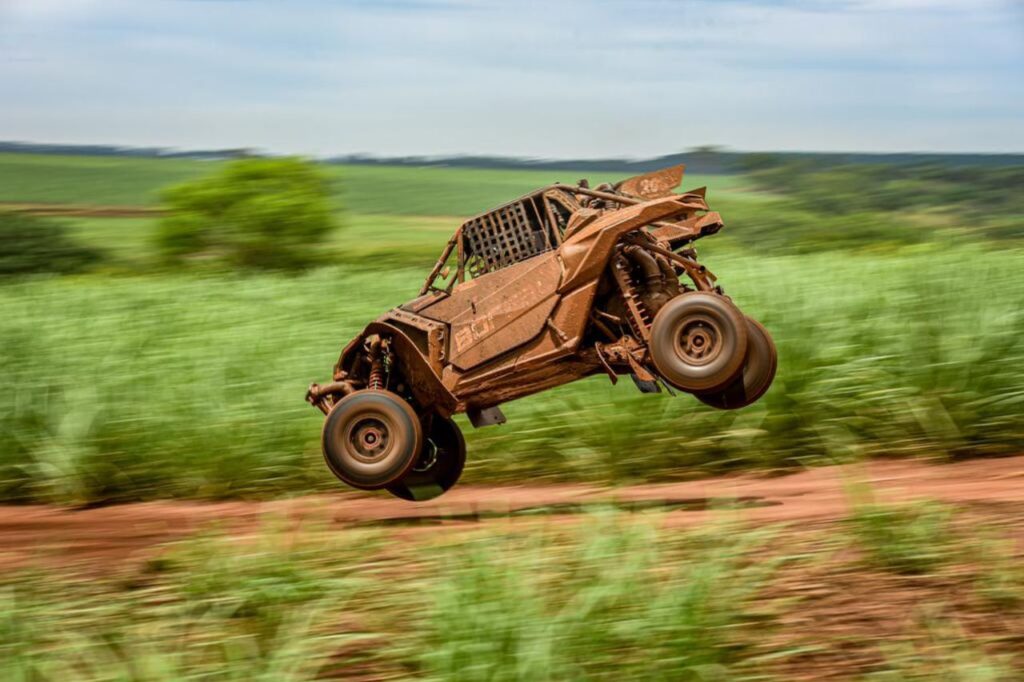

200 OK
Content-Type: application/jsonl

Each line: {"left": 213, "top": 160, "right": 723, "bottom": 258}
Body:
{"left": 387, "top": 415, "right": 466, "bottom": 502}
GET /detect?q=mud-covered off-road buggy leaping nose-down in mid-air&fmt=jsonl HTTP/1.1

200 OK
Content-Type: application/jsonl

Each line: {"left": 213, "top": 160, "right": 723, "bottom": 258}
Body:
{"left": 306, "top": 166, "right": 776, "bottom": 500}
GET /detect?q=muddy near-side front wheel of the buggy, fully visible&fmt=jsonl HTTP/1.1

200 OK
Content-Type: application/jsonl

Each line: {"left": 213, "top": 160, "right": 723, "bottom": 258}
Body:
{"left": 323, "top": 390, "right": 423, "bottom": 491}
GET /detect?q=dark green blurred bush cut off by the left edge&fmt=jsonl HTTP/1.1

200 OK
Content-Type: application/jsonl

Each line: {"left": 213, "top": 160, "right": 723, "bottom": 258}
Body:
{"left": 0, "top": 212, "right": 99, "bottom": 276}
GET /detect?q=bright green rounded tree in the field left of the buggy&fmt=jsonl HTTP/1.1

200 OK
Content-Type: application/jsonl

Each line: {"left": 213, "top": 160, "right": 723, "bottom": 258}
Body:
{"left": 158, "top": 158, "right": 334, "bottom": 268}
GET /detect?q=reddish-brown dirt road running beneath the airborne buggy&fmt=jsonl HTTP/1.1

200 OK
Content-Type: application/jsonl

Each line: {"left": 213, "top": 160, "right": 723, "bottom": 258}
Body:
{"left": 0, "top": 456, "right": 1024, "bottom": 567}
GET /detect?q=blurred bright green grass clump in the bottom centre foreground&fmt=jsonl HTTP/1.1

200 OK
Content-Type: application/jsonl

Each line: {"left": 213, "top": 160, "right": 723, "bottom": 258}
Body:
{"left": 419, "top": 514, "right": 777, "bottom": 682}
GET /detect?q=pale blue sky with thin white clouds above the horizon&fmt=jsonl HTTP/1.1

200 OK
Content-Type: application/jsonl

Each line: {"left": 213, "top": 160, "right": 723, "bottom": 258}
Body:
{"left": 0, "top": 0, "right": 1024, "bottom": 158}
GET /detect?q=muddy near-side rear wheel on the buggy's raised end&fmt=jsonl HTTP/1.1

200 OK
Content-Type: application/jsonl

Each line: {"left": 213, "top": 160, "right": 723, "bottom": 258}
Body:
{"left": 650, "top": 291, "right": 746, "bottom": 393}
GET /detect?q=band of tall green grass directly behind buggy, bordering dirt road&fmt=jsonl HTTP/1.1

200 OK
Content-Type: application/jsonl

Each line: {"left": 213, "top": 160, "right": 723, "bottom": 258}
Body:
{"left": 0, "top": 245, "right": 1024, "bottom": 502}
